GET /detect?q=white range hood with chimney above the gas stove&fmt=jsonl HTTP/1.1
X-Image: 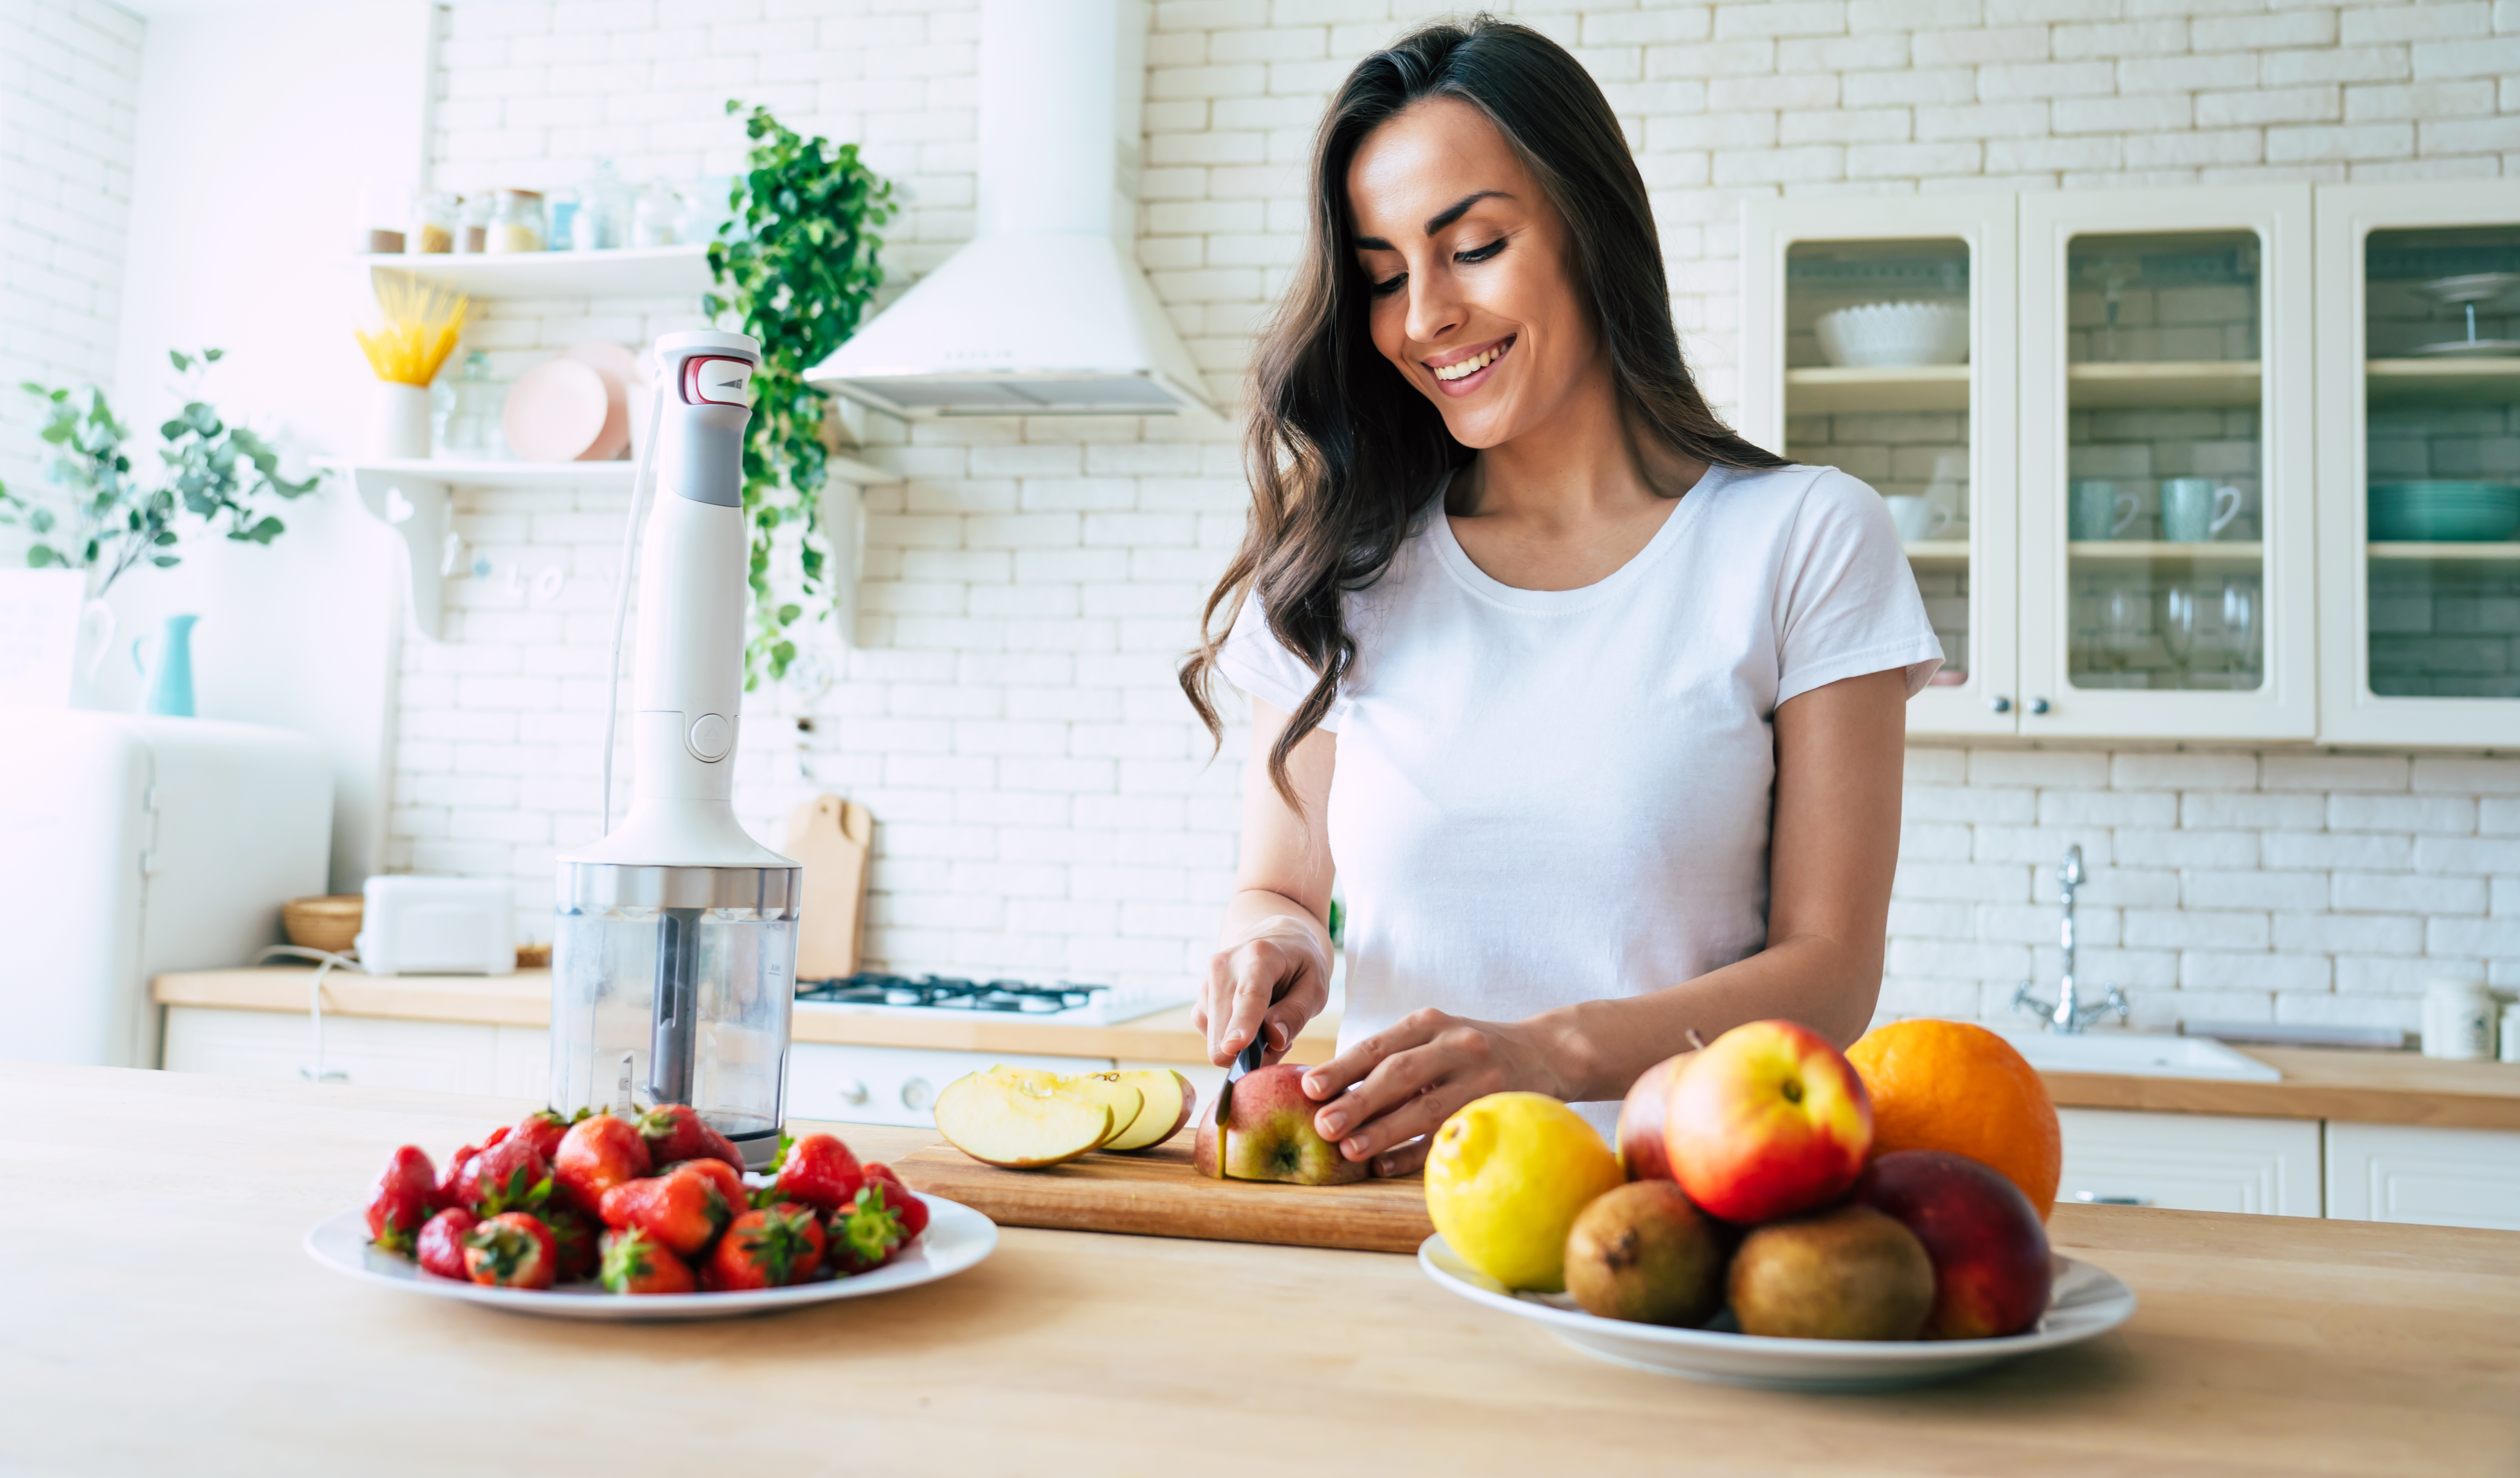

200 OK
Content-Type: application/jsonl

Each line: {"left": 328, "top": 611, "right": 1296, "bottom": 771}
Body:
{"left": 806, "top": 0, "right": 1215, "bottom": 416}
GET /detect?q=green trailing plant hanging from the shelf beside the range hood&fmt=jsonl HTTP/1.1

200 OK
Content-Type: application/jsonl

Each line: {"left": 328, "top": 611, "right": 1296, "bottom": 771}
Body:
{"left": 700, "top": 101, "right": 894, "bottom": 689}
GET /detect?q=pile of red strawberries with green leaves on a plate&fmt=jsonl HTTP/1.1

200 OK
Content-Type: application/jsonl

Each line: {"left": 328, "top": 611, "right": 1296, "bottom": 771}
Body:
{"left": 365, "top": 1105, "right": 927, "bottom": 1294}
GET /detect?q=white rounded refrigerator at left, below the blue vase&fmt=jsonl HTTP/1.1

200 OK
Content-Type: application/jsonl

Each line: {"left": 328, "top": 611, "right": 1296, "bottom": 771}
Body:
{"left": 0, "top": 709, "right": 333, "bottom": 1067}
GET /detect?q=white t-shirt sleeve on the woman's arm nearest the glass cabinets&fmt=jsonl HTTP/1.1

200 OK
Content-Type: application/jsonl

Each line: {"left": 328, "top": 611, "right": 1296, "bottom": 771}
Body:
{"left": 1777, "top": 467, "right": 1943, "bottom": 703}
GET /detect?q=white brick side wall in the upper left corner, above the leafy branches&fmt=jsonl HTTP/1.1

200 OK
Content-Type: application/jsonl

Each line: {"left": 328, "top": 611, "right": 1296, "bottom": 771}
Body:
{"left": 0, "top": 0, "right": 144, "bottom": 517}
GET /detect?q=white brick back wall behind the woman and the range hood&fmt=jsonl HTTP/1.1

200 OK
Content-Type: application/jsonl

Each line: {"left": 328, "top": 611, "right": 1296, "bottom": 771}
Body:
{"left": 396, "top": 0, "right": 2520, "bottom": 1024}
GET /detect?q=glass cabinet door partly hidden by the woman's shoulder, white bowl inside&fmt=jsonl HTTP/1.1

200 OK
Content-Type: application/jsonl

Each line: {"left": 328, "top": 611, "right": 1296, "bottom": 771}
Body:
{"left": 1741, "top": 197, "right": 2016, "bottom": 734}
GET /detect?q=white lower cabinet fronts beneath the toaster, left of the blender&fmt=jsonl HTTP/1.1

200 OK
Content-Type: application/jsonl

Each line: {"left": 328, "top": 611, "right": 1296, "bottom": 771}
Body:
{"left": 164, "top": 1006, "right": 552, "bottom": 1097}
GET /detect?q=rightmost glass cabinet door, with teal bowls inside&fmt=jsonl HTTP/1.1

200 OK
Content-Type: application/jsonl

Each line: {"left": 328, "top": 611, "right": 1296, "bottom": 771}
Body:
{"left": 2318, "top": 182, "right": 2520, "bottom": 744}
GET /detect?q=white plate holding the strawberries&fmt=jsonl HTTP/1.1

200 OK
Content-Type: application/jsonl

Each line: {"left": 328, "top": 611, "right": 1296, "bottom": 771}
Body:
{"left": 308, "top": 1196, "right": 998, "bottom": 1321}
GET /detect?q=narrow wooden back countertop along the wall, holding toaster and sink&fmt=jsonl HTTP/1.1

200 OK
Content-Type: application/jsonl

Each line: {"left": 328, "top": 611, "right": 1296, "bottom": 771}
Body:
{"left": 154, "top": 966, "right": 2520, "bottom": 1130}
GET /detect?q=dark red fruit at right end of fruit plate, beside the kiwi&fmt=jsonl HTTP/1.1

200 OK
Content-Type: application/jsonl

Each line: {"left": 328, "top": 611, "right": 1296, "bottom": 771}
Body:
{"left": 1855, "top": 1150, "right": 2054, "bottom": 1339}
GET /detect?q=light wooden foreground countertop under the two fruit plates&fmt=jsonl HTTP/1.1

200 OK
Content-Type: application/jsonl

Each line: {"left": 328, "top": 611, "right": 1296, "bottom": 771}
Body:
{"left": 0, "top": 1064, "right": 2520, "bottom": 1478}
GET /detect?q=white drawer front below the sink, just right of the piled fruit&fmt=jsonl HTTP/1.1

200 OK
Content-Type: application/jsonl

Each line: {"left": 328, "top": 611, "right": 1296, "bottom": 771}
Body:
{"left": 2056, "top": 1110, "right": 2321, "bottom": 1216}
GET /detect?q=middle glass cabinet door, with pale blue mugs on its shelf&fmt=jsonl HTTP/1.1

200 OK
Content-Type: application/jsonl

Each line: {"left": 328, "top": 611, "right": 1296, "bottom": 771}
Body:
{"left": 2021, "top": 187, "right": 2316, "bottom": 739}
